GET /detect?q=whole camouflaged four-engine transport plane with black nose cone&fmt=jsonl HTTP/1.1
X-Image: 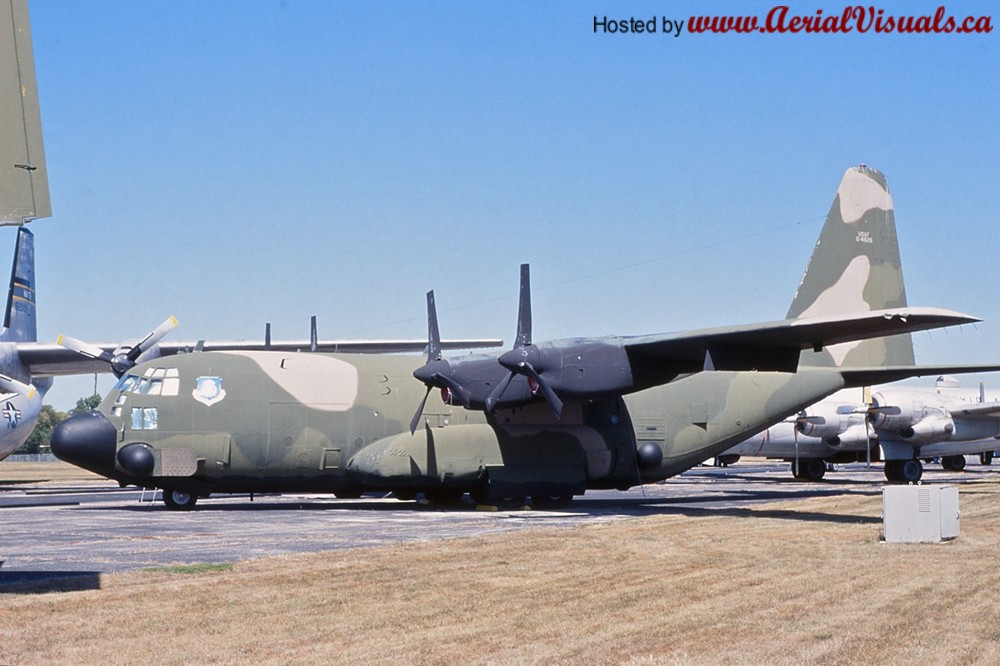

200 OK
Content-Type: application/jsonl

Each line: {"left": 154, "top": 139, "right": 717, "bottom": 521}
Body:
{"left": 52, "top": 165, "right": 992, "bottom": 509}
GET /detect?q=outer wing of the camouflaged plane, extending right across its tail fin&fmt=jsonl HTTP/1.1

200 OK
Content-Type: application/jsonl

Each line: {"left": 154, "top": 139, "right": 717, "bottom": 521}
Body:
{"left": 622, "top": 307, "right": 979, "bottom": 376}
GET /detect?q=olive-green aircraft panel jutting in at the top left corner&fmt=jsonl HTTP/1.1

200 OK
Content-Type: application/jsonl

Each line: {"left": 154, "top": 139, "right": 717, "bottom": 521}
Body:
{"left": 0, "top": 0, "right": 52, "bottom": 224}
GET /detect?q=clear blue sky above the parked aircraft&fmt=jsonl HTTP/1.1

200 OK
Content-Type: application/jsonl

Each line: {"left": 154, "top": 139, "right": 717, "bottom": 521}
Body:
{"left": 17, "top": 0, "right": 1000, "bottom": 409}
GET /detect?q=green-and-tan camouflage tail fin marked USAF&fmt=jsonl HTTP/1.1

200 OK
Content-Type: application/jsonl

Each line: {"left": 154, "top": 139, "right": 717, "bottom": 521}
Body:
{"left": 788, "top": 164, "right": 914, "bottom": 367}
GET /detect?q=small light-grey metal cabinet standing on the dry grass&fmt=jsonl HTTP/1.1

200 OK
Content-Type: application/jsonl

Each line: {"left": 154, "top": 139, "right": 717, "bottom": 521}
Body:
{"left": 882, "top": 486, "right": 959, "bottom": 543}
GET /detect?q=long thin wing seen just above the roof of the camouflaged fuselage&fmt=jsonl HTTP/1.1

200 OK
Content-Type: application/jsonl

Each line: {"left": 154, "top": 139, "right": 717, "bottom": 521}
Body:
{"left": 17, "top": 339, "right": 503, "bottom": 377}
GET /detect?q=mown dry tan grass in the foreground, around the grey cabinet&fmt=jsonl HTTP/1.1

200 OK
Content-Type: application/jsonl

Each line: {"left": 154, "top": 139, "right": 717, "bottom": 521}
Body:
{"left": 0, "top": 470, "right": 1000, "bottom": 664}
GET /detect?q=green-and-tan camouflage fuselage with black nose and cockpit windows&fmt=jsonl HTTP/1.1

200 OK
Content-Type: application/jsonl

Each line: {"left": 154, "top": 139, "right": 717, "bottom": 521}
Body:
{"left": 52, "top": 352, "right": 843, "bottom": 497}
